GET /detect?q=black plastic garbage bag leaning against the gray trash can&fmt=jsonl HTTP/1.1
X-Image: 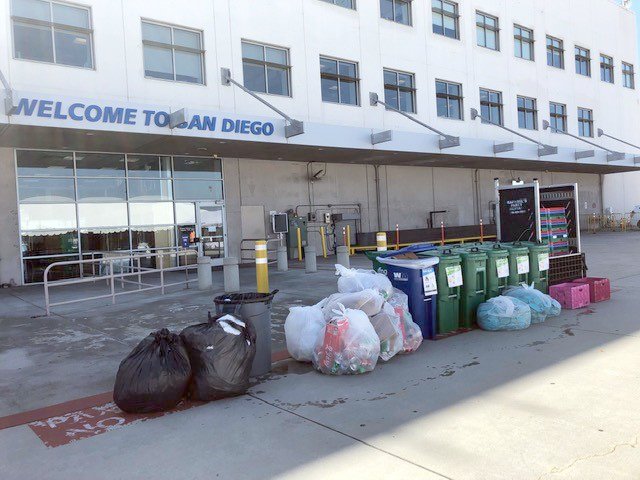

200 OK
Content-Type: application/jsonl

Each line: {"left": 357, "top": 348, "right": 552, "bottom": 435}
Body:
{"left": 180, "top": 314, "right": 256, "bottom": 401}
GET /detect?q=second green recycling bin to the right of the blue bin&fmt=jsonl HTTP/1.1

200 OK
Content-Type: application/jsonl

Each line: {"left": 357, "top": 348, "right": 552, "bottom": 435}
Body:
{"left": 454, "top": 246, "right": 488, "bottom": 328}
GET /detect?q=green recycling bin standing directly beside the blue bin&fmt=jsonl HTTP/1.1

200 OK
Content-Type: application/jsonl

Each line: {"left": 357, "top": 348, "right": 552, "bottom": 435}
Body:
{"left": 418, "top": 249, "right": 464, "bottom": 335}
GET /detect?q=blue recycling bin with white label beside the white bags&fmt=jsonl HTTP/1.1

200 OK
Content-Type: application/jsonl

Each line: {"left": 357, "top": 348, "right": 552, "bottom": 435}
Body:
{"left": 378, "top": 257, "right": 440, "bottom": 339}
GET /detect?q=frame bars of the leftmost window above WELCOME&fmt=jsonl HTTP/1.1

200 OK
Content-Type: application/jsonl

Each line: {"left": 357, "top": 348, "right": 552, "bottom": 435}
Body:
{"left": 9, "top": 0, "right": 96, "bottom": 71}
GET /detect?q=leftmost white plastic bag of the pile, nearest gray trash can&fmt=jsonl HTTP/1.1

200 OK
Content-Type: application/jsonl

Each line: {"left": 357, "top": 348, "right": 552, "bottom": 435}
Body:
{"left": 284, "top": 305, "right": 326, "bottom": 362}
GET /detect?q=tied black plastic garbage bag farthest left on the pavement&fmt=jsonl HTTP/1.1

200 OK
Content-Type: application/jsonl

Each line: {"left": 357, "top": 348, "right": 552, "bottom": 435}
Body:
{"left": 113, "top": 328, "right": 191, "bottom": 413}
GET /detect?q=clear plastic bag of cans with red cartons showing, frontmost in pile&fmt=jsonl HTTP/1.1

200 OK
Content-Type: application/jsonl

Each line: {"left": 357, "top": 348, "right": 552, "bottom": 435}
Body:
{"left": 313, "top": 305, "right": 380, "bottom": 375}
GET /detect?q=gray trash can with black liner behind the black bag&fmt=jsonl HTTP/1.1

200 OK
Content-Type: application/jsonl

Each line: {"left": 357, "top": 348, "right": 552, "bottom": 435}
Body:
{"left": 213, "top": 290, "right": 278, "bottom": 377}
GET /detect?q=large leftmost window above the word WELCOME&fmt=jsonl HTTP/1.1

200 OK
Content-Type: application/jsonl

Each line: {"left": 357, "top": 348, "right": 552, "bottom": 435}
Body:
{"left": 11, "top": 0, "right": 93, "bottom": 68}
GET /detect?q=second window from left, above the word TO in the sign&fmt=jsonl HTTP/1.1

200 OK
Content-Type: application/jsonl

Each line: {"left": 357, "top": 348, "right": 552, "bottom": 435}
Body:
{"left": 142, "top": 22, "right": 204, "bottom": 84}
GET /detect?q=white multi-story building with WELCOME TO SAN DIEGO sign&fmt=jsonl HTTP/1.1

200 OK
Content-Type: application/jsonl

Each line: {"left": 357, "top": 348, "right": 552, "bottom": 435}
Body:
{"left": 0, "top": 0, "right": 640, "bottom": 284}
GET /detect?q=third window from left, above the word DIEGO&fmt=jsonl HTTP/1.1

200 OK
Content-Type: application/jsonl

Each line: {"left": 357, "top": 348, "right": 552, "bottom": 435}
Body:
{"left": 242, "top": 42, "right": 291, "bottom": 97}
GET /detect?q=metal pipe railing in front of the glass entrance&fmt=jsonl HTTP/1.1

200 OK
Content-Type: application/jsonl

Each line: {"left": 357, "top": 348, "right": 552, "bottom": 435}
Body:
{"left": 43, "top": 250, "right": 197, "bottom": 316}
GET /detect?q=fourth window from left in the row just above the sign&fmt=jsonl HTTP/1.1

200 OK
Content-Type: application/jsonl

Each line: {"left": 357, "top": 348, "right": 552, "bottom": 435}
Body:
{"left": 320, "top": 57, "right": 360, "bottom": 105}
